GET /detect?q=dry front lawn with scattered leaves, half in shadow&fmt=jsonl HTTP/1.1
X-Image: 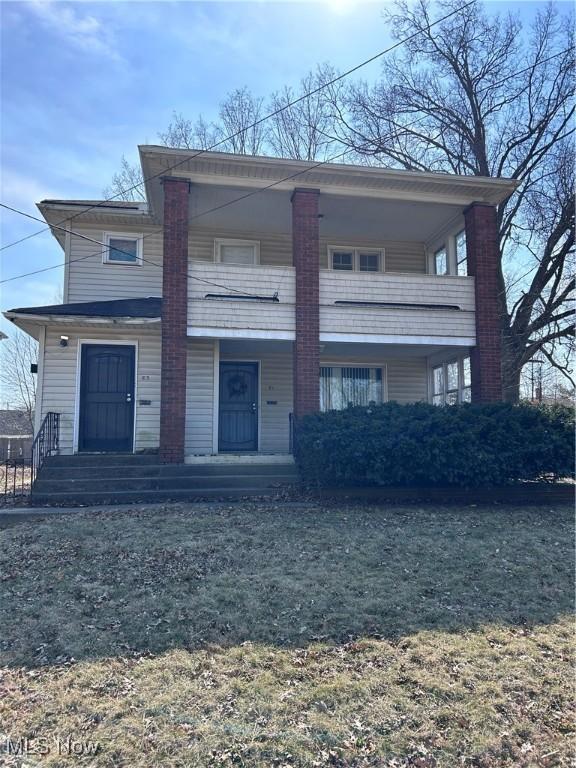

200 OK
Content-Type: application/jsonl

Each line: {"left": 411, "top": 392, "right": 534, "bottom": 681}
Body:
{"left": 0, "top": 504, "right": 574, "bottom": 768}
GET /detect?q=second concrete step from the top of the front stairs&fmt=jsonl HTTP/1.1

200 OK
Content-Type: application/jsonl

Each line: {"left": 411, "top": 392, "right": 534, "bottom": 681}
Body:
{"left": 40, "top": 463, "right": 297, "bottom": 480}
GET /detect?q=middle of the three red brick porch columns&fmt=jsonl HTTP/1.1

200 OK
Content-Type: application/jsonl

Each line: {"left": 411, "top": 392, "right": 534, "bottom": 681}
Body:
{"left": 292, "top": 189, "right": 320, "bottom": 419}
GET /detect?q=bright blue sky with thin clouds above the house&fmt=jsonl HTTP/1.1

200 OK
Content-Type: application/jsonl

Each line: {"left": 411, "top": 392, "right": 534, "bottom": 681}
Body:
{"left": 0, "top": 0, "right": 556, "bottom": 340}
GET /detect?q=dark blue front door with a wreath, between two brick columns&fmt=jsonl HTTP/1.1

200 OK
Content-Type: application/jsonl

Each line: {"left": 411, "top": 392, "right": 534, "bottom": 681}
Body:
{"left": 218, "top": 362, "right": 258, "bottom": 452}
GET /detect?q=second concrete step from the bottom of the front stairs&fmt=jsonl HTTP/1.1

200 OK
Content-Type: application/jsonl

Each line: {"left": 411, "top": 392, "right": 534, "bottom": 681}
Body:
{"left": 34, "top": 472, "right": 296, "bottom": 494}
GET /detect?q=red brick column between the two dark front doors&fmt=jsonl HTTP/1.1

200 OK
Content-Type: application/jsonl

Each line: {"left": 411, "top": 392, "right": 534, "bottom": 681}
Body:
{"left": 160, "top": 176, "right": 190, "bottom": 464}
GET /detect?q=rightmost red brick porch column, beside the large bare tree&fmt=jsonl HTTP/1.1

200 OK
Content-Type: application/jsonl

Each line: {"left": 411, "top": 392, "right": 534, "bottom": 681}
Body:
{"left": 464, "top": 203, "right": 502, "bottom": 403}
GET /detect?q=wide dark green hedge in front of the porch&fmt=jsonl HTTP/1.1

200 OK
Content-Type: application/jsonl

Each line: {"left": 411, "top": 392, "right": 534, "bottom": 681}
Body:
{"left": 295, "top": 403, "right": 574, "bottom": 487}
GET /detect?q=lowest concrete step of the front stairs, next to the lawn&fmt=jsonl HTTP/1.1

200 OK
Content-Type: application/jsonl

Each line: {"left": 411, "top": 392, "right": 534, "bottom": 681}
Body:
{"left": 32, "top": 488, "right": 296, "bottom": 506}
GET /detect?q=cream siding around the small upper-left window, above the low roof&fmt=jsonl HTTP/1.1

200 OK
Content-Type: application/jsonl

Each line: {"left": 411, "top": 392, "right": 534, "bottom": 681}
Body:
{"left": 67, "top": 226, "right": 162, "bottom": 302}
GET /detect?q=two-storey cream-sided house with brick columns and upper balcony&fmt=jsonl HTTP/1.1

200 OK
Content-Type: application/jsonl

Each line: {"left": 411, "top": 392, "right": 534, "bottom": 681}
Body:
{"left": 5, "top": 146, "right": 516, "bottom": 463}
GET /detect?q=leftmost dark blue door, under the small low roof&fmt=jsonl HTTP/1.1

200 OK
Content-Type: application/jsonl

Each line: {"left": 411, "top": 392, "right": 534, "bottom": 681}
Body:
{"left": 78, "top": 344, "right": 135, "bottom": 453}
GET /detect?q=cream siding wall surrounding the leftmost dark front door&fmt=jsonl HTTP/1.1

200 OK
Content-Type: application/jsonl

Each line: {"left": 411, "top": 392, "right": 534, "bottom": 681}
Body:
{"left": 42, "top": 327, "right": 160, "bottom": 453}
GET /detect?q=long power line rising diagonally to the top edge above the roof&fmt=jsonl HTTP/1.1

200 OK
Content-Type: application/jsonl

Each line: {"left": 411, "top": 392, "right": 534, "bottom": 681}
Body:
{"left": 0, "top": 0, "right": 476, "bottom": 251}
